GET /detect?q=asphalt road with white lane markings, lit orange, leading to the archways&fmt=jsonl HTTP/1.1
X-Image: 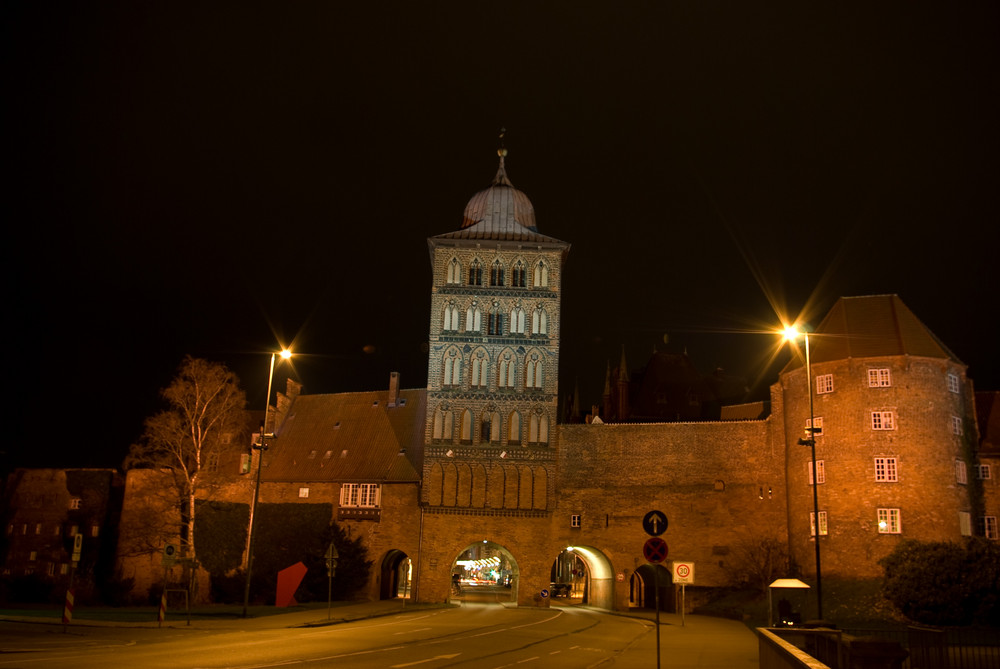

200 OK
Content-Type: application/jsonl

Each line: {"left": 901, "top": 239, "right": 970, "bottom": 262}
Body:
{"left": 0, "top": 603, "right": 757, "bottom": 669}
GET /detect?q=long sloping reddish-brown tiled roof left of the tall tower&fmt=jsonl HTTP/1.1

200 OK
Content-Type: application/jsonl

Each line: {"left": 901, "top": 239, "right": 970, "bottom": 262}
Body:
{"left": 261, "top": 389, "right": 427, "bottom": 483}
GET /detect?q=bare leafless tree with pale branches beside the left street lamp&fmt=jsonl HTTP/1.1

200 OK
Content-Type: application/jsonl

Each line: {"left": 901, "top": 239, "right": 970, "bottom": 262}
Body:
{"left": 124, "top": 356, "right": 247, "bottom": 560}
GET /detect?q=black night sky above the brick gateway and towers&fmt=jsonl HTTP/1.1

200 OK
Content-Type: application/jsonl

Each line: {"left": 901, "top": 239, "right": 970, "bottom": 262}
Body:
{"left": 7, "top": 2, "right": 1000, "bottom": 467}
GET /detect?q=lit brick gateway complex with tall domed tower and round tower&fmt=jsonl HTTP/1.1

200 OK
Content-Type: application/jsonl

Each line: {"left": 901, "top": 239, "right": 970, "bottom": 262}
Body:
{"left": 109, "top": 152, "right": 997, "bottom": 610}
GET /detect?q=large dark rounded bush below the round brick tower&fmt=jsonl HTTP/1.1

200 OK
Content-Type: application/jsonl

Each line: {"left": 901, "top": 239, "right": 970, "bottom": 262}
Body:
{"left": 881, "top": 539, "right": 1000, "bottom": 625}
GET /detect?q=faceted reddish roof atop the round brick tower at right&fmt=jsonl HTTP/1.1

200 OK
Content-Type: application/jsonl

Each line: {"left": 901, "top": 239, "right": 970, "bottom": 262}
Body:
{"left": 782, "top": 295, "right": 962, "bottom": 373}
